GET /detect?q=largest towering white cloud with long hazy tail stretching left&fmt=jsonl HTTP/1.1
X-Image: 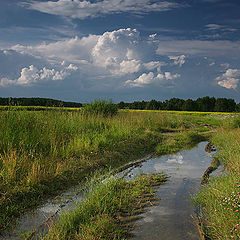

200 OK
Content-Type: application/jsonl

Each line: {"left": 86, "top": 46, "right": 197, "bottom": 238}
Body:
{"left": 11, "top": 28, "right": 145, "bottom": 76}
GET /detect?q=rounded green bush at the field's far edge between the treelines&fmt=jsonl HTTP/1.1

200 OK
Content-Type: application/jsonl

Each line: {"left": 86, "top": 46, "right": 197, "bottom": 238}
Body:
{"left": 83, "top": 100, "right": 118, "bottom": 117}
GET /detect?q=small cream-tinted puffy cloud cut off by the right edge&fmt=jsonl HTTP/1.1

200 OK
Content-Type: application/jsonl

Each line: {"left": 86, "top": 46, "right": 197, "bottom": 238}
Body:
{"left": 216, "top": 69, "right": 240, "bottom": 89}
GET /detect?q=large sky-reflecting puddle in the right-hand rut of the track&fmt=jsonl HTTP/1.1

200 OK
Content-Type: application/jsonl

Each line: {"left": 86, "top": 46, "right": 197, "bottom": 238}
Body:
{"left": 124, "top": 142, "right": 218, "bottom": 240}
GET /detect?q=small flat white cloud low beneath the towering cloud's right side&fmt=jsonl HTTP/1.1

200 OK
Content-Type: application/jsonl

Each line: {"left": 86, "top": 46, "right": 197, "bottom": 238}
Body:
{"left": 125, "top": 72, "right": 180, "bottom": 87}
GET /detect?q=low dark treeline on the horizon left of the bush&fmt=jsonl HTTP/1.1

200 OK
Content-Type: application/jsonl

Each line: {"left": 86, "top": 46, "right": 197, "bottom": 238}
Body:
{"left": 0, "top": 98, "right": 82, "bottom": 107}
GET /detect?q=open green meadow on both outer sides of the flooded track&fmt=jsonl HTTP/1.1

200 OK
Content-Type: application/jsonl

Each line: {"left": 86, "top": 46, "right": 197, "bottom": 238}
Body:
{"left": 0, "top": 108, "right": 240, "bottom": 239}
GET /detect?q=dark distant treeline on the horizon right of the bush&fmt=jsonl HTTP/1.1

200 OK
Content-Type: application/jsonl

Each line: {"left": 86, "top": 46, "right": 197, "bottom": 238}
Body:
{"left": 118, "top": 97, "right": 240, "bottom": 112}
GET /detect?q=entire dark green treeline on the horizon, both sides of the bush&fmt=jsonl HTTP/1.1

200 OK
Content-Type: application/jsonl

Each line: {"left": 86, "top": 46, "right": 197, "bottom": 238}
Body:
{"left": 0, "top": 96, "right": 240, "bottom": 112}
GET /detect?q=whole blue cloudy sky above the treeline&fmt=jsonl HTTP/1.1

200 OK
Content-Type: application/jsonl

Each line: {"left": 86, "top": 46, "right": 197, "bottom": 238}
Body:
{"left": 0, "top": 0, "right": 240, "bottom": 103}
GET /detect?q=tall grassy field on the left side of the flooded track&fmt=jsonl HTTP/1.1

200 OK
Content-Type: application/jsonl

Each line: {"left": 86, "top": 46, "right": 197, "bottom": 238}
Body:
{"left": 0, "top": 110, "right": 227, "bottom": 231}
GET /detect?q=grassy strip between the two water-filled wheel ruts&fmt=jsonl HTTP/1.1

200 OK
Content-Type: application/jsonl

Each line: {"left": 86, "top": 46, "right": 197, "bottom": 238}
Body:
{"left": 44, "top": 174, "right": 166, "bottom": 240}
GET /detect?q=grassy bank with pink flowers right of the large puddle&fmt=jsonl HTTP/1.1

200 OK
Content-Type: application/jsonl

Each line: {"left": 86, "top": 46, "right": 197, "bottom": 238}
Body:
{"left": 195, "top": 126, "right": 240, "bottom": 240}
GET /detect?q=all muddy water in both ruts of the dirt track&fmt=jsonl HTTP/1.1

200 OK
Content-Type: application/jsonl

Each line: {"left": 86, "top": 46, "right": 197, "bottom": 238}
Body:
{"left": 0, "top": 142, "right": 219, "bottom": 240}
